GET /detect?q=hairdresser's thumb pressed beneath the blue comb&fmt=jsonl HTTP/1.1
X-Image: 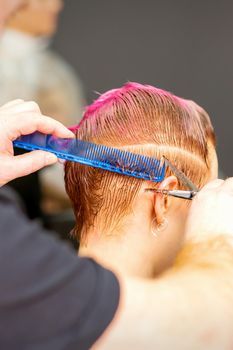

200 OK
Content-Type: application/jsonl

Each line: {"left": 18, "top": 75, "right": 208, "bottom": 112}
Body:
{"left": 5, "top": 151, "right": 57, "bottom": 180}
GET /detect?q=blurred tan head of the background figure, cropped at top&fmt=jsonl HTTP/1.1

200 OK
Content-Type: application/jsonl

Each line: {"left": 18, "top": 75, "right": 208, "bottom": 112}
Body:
{"left": 8, "top": 0, "right": 63, "bottom": 37}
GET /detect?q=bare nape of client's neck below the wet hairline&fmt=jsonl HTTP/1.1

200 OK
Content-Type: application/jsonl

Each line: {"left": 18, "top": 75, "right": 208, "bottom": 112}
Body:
{"left": 79, "top": 219, "right": 178, "bottom": 278}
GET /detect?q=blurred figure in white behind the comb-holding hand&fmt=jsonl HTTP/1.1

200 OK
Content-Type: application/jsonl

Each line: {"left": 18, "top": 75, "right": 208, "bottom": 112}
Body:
{"left": 0, "top": 0, "right": 85, "bottom": 218}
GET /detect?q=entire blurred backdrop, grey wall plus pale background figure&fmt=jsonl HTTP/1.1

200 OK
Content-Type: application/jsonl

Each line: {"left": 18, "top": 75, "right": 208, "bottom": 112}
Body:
{"left": 0, "top": 0, "right": 233, "bottom": 246}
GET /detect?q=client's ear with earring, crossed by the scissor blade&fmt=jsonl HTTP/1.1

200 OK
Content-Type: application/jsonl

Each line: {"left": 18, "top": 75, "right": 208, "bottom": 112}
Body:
{"left": 154, "top": 176, "right": 178, "bottom": 224}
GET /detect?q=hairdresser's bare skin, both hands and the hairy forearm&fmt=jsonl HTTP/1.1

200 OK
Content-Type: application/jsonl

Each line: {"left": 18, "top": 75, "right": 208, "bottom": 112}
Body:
{"left": 0, "top": 0, "right": 233, "bottom": 350}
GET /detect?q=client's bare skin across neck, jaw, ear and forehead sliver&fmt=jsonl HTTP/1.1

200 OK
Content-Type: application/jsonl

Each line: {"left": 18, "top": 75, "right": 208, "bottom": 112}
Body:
{"left": 79, "top": 147, "right": 218, "bottom": 278}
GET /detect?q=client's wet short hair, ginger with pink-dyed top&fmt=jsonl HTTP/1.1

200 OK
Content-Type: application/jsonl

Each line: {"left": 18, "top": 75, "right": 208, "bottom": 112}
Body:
{"left": 65, "top": 83, "right": 215, "bottom": 243}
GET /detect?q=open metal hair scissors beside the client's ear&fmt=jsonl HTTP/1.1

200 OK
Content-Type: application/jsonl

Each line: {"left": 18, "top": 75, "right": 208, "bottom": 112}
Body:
{"left": 146, "top": 156, "right": 199, "bottom": 200}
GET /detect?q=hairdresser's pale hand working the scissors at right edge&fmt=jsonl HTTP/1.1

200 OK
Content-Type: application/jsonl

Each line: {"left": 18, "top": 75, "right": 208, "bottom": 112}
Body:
{"left": 186, "top": 178, "right": 233, "bottom": 240}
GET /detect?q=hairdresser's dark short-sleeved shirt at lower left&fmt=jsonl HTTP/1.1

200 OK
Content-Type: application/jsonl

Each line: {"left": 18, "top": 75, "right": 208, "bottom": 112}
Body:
{"left": 0, "top": 189, "right": 120, "bottom": 350}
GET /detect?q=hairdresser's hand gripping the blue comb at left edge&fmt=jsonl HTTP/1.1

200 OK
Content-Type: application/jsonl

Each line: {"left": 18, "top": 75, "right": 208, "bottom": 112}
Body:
{"left": 0, "top": 100, "right": 73, "bottom": 186}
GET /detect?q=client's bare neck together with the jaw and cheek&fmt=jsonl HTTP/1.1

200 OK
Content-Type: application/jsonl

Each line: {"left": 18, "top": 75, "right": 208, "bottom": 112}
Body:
{"left": 79, "top": 203, "right": 187, "bottom": 278}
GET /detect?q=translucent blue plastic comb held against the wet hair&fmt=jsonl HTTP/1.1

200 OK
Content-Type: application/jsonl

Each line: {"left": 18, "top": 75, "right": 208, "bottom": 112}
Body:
{"left": 13, "top": 132, "right": 166, "bottom": 182}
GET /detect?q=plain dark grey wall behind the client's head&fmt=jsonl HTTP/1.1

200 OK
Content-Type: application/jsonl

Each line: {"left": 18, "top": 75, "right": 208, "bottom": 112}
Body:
{"left": 53, "top": 0, "right": 233, "bottom": 176}
